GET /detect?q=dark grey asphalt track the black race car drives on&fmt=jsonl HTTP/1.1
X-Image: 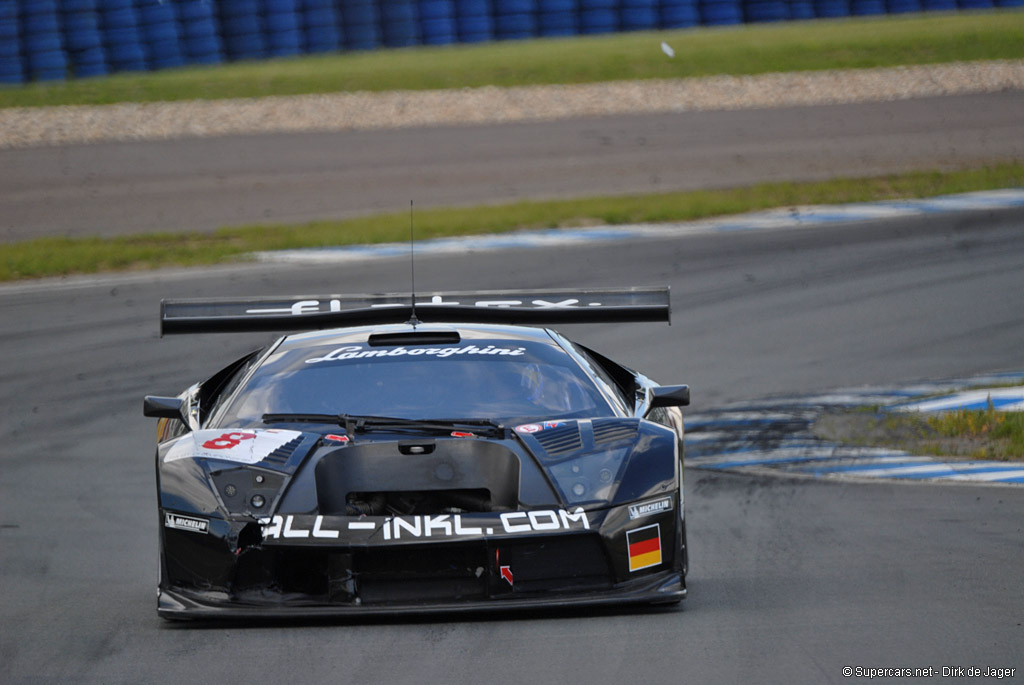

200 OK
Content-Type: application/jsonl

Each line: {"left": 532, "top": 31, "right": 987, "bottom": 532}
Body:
{"left": 0, "top": 204, "right": 1024, "bottom": 684}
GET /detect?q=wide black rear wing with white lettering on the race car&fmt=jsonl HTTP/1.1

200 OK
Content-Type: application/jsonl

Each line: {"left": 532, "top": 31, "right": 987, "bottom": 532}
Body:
{"left": 160, "top": 287, "right": 672, "bottom": 335}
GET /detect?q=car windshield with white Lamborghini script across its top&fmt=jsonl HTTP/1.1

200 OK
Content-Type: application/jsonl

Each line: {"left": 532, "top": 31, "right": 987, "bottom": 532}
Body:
{"left": 217, "top": 340, "right": 614, "bottom": 427}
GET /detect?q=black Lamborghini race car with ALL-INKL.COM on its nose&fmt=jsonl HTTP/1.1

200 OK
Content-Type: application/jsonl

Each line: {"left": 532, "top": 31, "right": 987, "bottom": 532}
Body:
{"left": 143, "top": 289, "right": 689, "bottom": 618}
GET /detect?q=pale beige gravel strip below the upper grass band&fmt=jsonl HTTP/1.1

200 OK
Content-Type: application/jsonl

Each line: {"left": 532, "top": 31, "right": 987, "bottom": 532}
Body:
{"left": 0, "top": 60, "right": 1024, "bottom": 147}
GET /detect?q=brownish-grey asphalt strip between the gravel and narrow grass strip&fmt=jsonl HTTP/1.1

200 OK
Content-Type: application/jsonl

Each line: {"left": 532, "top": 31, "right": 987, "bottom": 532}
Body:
{"left": 0, "top": 91, "right": 1024, "bottom": 242}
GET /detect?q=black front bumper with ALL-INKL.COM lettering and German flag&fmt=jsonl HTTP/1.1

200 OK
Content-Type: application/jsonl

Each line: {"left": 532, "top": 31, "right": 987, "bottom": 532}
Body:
{"left": 158, "top": 499, "right": 686, "bottom": 618}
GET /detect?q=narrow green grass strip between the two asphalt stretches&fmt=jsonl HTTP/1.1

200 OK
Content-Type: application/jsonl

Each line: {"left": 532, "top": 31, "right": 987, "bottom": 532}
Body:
{"left": 0, "top": 163, "right": 1024, "bottom": 282}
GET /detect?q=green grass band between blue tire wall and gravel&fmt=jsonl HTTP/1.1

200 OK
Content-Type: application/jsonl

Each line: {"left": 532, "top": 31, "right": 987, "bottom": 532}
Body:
{"left": 0, "top": 9, "right": 1024, "bottom": 108}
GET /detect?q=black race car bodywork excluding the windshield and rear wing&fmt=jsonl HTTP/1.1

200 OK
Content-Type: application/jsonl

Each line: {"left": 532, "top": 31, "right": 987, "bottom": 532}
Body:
{"left": 147, "top": 315, "right": 687, "bottom": 618}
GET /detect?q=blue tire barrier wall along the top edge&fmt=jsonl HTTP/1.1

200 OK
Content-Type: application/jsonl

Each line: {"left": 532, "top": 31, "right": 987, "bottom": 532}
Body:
{"left": 0, "top": 0, "right": 1024, "bottom": 82}
